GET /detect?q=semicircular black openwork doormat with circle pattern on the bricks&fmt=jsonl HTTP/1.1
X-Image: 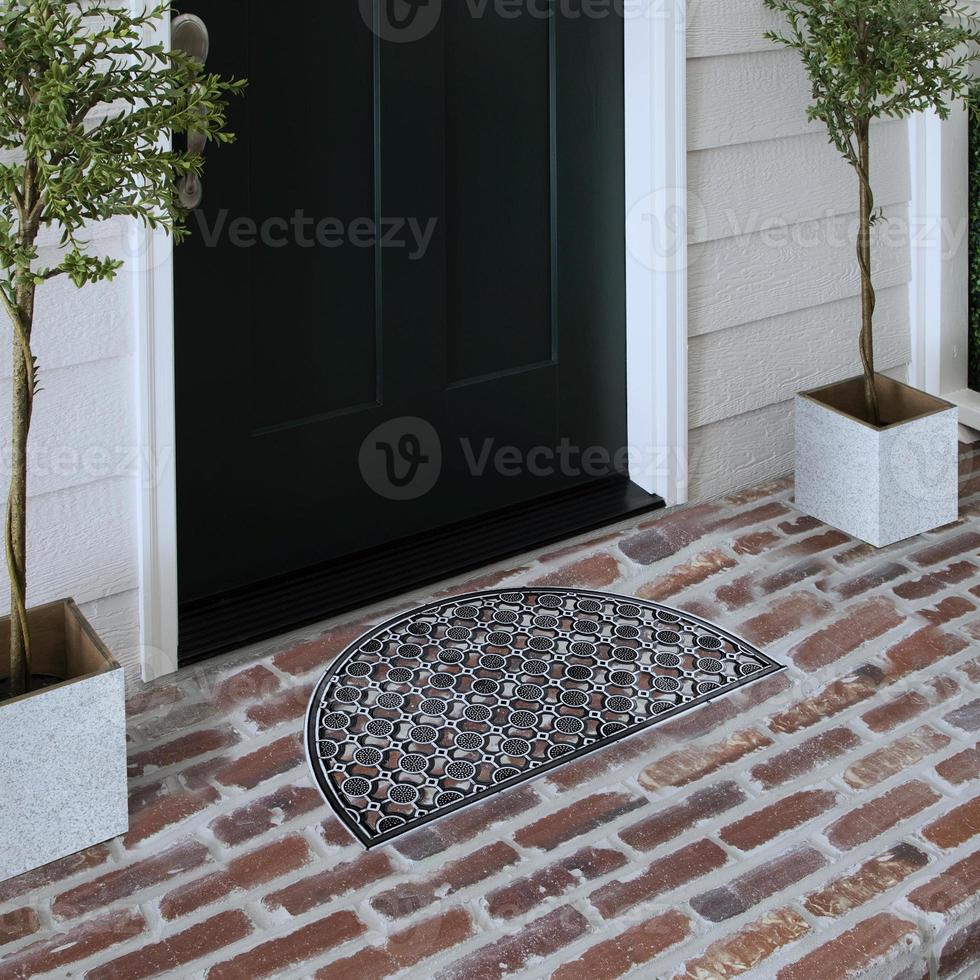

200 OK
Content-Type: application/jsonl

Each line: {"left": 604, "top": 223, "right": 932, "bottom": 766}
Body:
{"left": 306, "top": 589, "right": 783, "bottom": 847}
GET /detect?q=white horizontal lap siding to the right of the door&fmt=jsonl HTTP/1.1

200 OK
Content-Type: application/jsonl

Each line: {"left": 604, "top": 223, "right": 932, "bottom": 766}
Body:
{"left": 688, "top": 0, "right": 911, "bottom": 500}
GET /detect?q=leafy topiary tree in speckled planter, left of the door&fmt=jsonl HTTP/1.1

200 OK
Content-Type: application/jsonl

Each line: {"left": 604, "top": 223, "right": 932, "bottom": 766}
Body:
{"left": 0, "top": 0, "right": 242, "bottom": 880}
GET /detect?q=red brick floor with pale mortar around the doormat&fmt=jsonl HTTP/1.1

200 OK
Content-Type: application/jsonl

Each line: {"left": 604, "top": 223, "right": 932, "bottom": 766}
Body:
{"left": 0, "top": 447, "right": 980, "bottom": 980}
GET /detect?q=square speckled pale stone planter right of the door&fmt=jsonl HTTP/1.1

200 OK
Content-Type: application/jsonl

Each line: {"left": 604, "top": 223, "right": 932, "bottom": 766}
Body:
{"left": 796, "top": 375, "right": 958, "bottom": 548}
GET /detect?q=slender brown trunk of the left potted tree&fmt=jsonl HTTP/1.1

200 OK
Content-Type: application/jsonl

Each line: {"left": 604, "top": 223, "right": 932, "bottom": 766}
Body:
{"left": 6, "top": 286, "right": 34, "bottom": 697}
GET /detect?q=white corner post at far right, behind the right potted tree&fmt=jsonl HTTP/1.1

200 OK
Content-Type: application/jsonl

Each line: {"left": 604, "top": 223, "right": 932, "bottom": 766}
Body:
{"left": 909, "top": 104, "right": 980, "bottom": 437}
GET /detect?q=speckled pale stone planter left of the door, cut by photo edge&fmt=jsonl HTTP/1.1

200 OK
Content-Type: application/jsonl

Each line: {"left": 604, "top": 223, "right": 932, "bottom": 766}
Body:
{"left": 0, "top": 599, "right": 129, "bottom": 881}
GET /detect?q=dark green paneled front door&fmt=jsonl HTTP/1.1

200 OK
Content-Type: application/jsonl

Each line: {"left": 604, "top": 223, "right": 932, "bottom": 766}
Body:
{"left": 176, "top": 0, "right": 651, "bottom": 653}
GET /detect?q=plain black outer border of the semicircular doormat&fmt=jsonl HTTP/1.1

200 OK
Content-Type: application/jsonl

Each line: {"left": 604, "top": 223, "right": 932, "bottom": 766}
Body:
{"left": 303, "top": 585, "right": 786, "bottom": 850}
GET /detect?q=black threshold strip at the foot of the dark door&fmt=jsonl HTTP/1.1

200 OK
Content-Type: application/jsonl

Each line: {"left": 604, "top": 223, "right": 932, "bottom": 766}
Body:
{"left": 178, "top": 476, "right": 664, "bottom": 667}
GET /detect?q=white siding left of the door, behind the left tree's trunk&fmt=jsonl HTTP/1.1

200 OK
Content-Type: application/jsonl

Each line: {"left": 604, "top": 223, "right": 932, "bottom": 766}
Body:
{"left": 0, "top": 221, "right": 140, "bottom": 677}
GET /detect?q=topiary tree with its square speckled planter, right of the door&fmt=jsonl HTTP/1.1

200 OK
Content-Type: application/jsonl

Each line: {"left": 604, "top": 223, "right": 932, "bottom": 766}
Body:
{"left": 764, "top": 0, "right": 980, "bottom": 547}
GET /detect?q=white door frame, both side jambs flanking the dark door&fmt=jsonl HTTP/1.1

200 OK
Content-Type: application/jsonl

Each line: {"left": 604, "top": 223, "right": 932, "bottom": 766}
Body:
{"left": 134, "top": 0, "right": 687, "bottom": 680}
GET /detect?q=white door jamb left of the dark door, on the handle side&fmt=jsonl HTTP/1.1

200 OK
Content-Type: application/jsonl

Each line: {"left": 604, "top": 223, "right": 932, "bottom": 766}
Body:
{"left": 134, "top": 9, "right": 177, "bottom": 681}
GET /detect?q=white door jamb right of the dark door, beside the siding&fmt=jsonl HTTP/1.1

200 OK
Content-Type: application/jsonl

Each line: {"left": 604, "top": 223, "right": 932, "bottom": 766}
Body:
{"left": 624, "top": 0, "right": 688, "bottom": 506}
